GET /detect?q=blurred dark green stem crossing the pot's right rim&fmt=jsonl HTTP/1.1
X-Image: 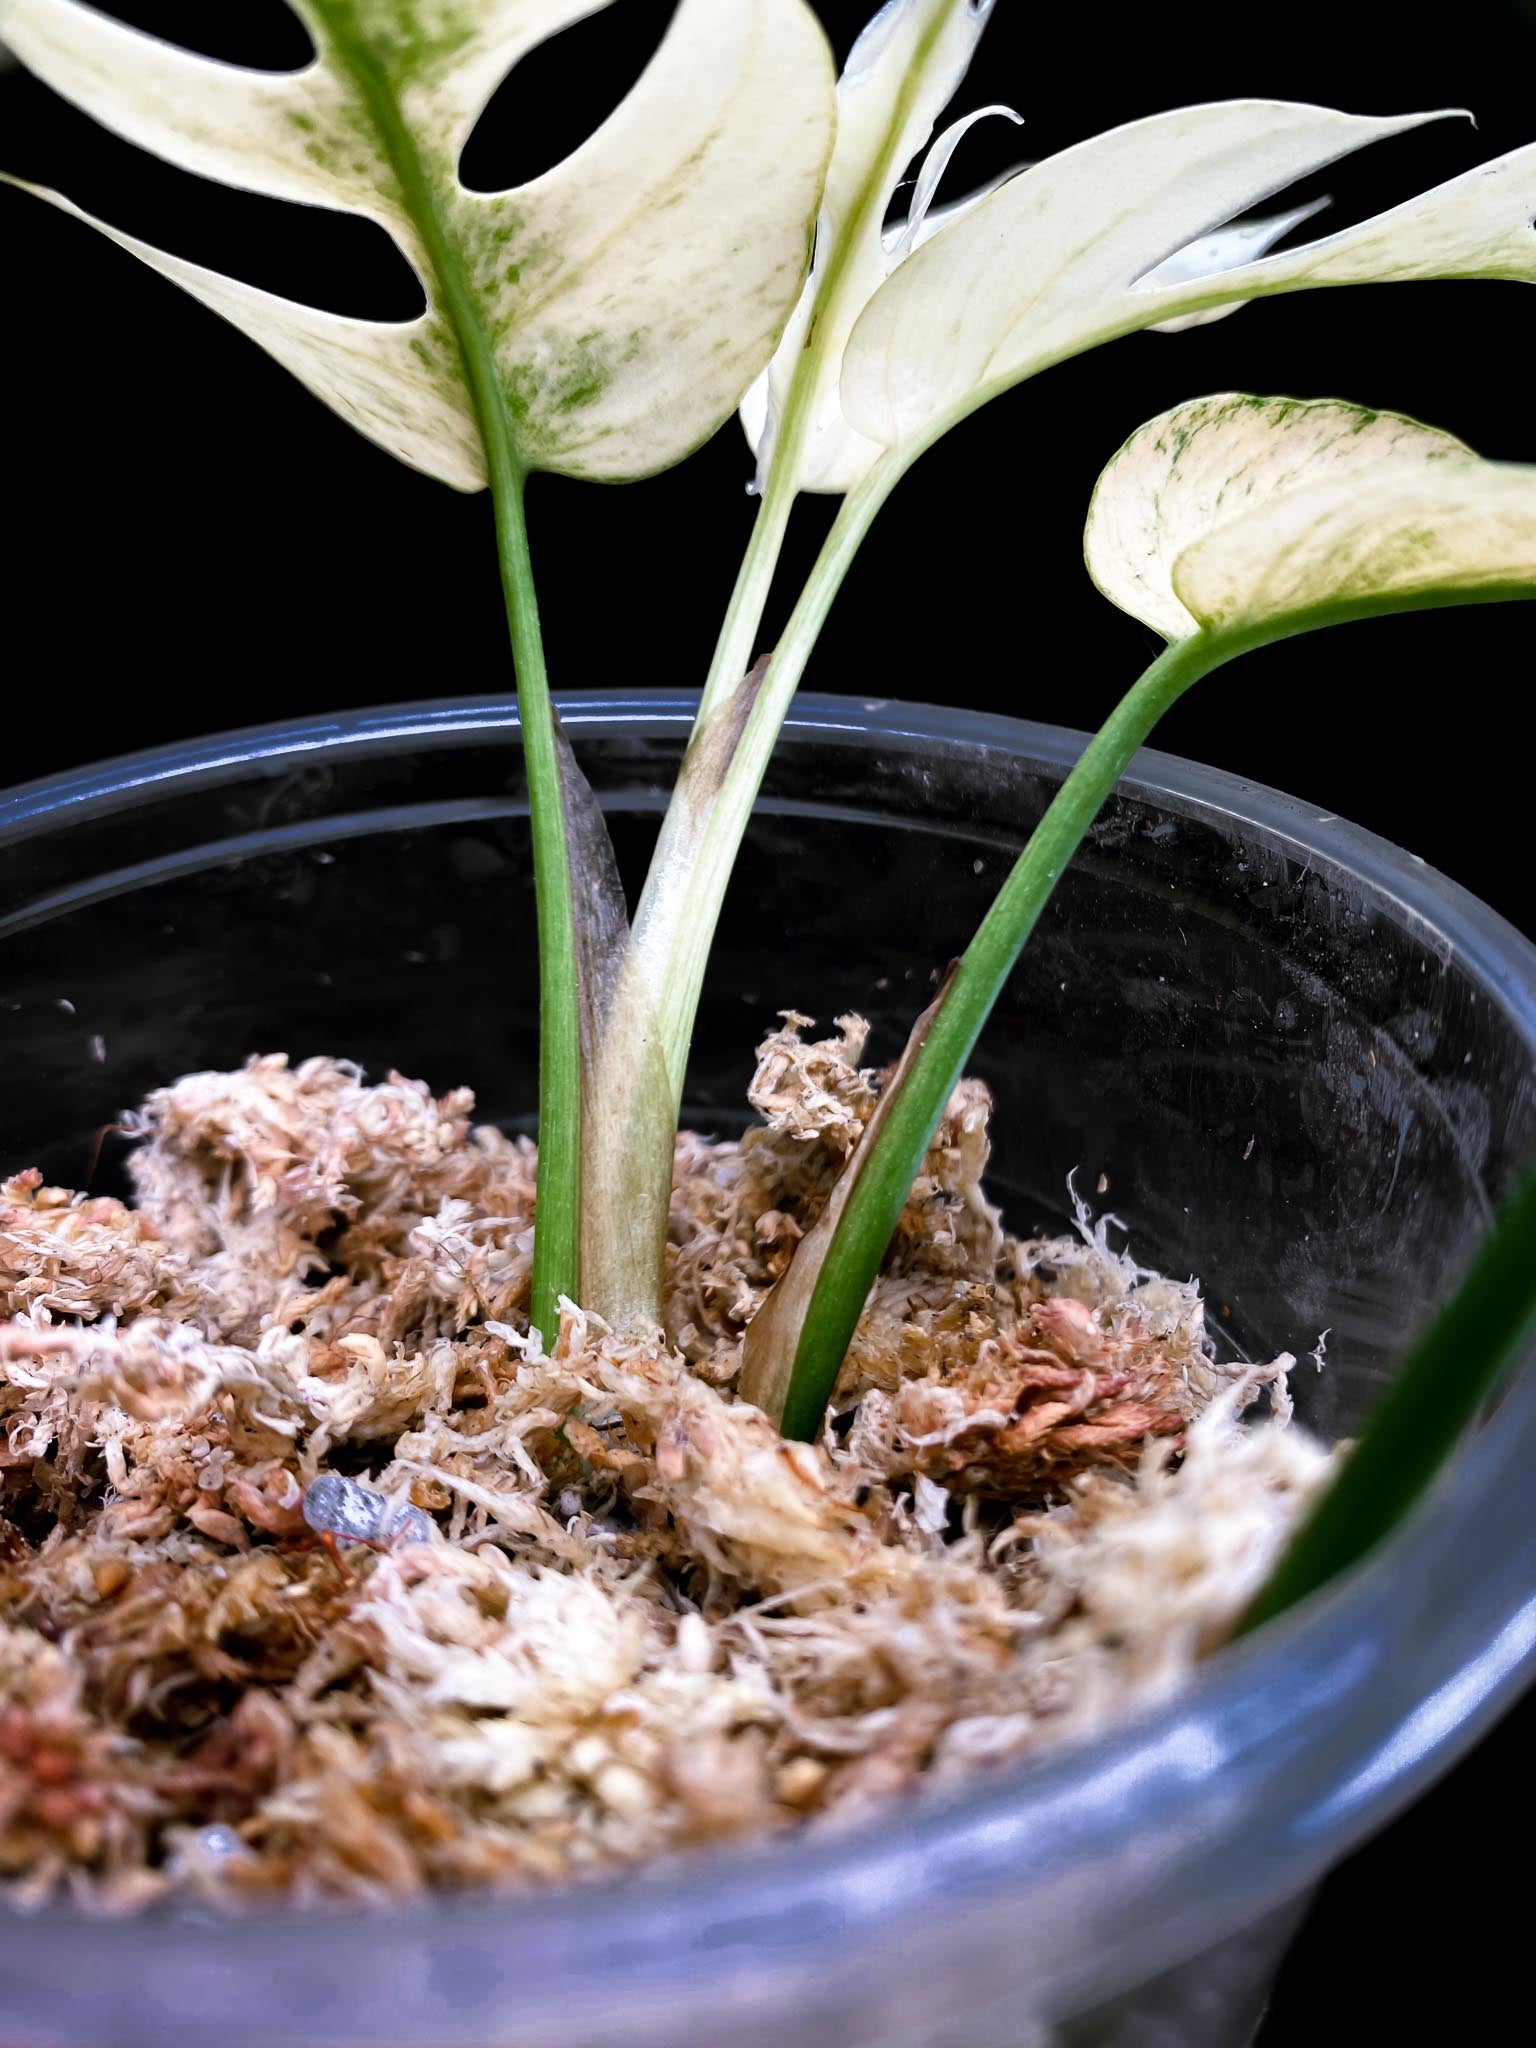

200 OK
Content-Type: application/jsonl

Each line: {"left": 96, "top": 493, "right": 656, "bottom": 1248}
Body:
{"left": 1235, "top": 1169, "right": 1536, "bottom": 1636}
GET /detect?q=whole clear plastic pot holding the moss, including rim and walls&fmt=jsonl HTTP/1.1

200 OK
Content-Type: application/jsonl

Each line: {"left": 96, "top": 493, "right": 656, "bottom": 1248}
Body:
{"left": 0, "top": 694, "right": 1536, "bottom": 2048}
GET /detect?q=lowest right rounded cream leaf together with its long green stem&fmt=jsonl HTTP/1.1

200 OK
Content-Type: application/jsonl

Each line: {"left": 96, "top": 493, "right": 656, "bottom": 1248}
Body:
{"left": 741, "top": 393, "right": 1536, "bottom": 1436}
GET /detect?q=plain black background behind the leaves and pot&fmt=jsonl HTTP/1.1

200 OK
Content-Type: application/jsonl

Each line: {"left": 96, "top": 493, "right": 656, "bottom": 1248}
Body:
{"left": 0, "top": 0, "right": 1536, "bottom": 2048}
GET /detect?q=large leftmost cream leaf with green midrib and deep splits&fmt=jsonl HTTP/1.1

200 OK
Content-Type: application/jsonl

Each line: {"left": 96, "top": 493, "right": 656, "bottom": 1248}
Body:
{"left": 0, "top": 0, "right": 834, "bottom": 487}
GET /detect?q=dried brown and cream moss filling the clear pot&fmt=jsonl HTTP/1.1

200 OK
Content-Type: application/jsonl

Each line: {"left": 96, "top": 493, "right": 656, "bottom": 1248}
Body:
{"left": 0, "top": 1032, "right": 1327, "bottom": 1907}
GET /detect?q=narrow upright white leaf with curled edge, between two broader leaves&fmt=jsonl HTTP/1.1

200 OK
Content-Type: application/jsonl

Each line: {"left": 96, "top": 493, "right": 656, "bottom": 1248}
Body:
{"left": 741, "top": 0, "right": 1003, "bottom": 492}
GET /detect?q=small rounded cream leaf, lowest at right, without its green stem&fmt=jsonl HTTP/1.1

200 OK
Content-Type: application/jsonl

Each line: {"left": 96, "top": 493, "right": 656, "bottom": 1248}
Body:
{"left": 1083, "top": 393, "right": 1536, "bottom": 641}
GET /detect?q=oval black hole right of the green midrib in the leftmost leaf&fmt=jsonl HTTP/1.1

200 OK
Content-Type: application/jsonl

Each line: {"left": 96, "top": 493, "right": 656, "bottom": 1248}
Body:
{"left": 459, "top": 0, "right": 676, "bottom": 193}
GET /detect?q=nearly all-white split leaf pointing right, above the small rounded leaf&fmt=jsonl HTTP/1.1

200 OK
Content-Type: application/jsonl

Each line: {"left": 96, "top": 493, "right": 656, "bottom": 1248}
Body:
{"left": 842, "top": 100, "right": 1536, "bottom": 466}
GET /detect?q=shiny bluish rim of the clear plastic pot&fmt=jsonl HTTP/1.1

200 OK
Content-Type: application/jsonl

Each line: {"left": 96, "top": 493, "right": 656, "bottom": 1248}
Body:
{"left": 0, "top": 690, "right": 1536, "bottom": 2042}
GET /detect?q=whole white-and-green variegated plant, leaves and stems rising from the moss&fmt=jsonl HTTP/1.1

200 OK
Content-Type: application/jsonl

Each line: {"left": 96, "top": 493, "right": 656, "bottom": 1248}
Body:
{"left": 0, "top": 0, "right": 1536, "bottom": 1490}
